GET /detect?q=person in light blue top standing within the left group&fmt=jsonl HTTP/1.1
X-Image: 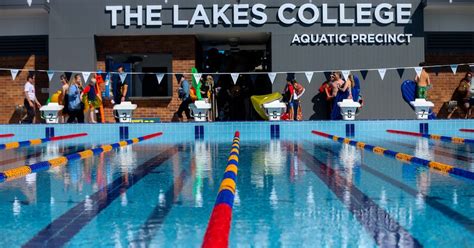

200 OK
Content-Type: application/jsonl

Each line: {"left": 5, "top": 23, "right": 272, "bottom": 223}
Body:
{"left": 67, "top": 74, "right": 84, "bottom": 123}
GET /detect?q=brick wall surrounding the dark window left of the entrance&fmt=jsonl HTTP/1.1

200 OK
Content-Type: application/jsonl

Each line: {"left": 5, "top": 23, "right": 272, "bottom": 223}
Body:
{"left": 96, "top": 35, "right": 196, "bottom": 122}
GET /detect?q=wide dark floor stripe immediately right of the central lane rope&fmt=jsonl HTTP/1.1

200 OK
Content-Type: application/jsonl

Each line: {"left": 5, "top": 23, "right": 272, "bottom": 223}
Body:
{"left": 298, "top": 146, "right": 422, "bottom": 247}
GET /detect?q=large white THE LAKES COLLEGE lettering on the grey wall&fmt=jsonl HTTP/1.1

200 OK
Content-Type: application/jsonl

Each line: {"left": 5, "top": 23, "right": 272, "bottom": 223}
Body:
{"left": 105, "top": 3, "right": 412, "bottom": 27}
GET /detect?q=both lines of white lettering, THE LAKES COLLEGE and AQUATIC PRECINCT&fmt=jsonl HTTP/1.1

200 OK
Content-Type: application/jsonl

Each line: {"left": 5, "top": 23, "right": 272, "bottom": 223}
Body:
{"left": 105, "top": 3, "right": 413, "bottom": 45}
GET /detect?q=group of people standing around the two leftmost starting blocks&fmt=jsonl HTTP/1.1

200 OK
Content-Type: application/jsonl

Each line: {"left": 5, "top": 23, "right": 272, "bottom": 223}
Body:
{"left": 21, "top": 66, "right": 128, "bottom": 124}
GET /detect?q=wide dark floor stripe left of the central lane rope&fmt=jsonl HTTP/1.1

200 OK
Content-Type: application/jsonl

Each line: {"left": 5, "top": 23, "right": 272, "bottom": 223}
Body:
{"left": 22, "top": 148, "right": 178, "bottom": 247}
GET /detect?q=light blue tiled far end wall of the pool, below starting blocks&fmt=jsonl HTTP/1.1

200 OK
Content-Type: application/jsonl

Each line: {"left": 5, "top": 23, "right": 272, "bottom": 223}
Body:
{"left": 0, "top": 120, "right": 474, "bottom": 143}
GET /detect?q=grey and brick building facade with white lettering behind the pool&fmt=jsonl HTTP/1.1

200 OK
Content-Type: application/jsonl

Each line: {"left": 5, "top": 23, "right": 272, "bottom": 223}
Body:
{"left": 0, "top": 0, "right": 474, "bottom": 123}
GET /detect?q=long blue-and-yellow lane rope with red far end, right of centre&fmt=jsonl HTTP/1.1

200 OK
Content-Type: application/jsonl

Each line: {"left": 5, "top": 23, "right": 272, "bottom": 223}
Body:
{"left": 312, "top": 130, "right": 474, "bottom": 180}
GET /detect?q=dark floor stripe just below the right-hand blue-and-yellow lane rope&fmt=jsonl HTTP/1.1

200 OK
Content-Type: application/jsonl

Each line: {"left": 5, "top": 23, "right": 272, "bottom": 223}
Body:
{"left": 313, "top": 144, "right": 474, "bottom": 233}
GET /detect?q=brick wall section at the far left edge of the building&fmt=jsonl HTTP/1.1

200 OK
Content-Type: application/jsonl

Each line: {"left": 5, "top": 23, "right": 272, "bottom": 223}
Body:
{"left": 0, "top": 55, "right": 48, "bottom": 124}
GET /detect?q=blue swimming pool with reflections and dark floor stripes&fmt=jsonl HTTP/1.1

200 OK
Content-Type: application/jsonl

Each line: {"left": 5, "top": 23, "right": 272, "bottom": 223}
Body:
{"left": 0, "top": 121, "right": 474, "bottom": 247}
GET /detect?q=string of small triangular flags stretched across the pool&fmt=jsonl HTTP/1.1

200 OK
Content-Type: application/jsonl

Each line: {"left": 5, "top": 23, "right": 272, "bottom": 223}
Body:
{"left": 0, "top": 63, "right": 474, "bottom": 84}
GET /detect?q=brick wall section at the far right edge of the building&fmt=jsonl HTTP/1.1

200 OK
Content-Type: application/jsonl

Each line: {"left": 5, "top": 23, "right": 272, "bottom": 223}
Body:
{"left": 426, "top": 51, "right": 474, "bottom": 118}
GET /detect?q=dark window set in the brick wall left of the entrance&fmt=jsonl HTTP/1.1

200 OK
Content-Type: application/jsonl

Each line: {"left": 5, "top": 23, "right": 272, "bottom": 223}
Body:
{"left": 106, "top": 54, "right": 173, "bottom": 99}
